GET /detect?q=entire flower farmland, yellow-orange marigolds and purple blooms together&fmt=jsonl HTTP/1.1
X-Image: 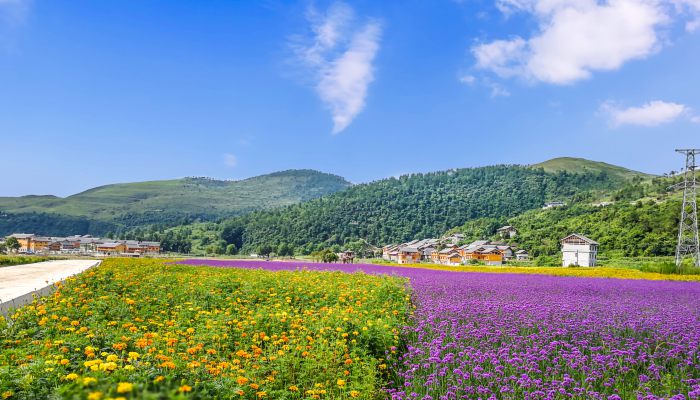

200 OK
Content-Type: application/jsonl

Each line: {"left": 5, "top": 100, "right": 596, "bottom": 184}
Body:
{"left": 0, "top": 260, "right": 700, "bottom": 399}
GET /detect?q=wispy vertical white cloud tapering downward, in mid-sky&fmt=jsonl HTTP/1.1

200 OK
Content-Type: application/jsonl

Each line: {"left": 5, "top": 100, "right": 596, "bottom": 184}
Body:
{"left": 293, "top": 3, "right": 382, "bottom": 134}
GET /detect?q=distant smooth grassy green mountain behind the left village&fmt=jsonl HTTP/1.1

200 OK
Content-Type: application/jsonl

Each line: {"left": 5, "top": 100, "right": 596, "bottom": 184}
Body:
{"left": 0, "top": 170, "right": 350, "bottom": 235}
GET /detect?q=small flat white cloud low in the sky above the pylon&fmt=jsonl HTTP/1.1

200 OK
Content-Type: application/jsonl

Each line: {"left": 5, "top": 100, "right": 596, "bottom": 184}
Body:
{"left": 601, "top": 100, "right": 697, "bottom": 127}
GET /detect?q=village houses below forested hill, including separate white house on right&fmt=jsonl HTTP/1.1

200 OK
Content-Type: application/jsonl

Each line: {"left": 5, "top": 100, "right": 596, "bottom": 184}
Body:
{"left": 382, "top": 225, "right": 598, "bottom": 267}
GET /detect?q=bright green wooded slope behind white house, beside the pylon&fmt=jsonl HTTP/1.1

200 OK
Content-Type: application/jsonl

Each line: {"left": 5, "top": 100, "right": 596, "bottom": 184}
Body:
{"left": 451, "top": 177, "right": 682, "bottom": 256}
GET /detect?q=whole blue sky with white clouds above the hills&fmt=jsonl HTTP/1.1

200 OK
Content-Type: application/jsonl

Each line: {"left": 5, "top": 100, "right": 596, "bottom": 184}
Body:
{"left": 0, "top": 0, "right": 700, "bottom": 196}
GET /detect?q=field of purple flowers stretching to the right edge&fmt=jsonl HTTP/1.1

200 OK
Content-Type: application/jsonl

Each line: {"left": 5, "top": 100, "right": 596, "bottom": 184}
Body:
{"left": 178, "top": 260, "right": 700, "bottom": 399}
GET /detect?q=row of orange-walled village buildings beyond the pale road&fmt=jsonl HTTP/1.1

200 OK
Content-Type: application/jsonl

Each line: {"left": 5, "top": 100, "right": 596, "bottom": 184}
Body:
{"left": 5, "top": 233, "right": 160, "bottom": 257}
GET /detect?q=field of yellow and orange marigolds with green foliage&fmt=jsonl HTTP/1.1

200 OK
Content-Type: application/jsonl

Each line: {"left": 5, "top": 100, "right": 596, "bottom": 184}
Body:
{"left": 0, "top": 259, "right": 409, "bottom": 400}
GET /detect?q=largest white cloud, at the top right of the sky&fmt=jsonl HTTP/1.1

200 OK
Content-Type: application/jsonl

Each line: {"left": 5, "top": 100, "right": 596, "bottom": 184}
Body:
{"left": 471, "top": 0, "right": 700, "bottom": 84}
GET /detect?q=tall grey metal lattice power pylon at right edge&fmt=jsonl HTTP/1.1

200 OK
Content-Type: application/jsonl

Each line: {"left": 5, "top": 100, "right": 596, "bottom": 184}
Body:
{"left": 673, "top": 149, "right": 700, "bottom": 267}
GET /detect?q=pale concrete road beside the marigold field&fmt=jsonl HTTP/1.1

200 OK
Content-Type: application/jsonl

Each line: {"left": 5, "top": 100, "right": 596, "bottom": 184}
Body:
{"left": 0, "top": 260, "right": 99, "bottom": 311}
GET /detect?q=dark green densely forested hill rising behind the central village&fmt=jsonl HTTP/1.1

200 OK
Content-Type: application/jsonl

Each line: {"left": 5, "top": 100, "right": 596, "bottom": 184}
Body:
{"left": 134, "top": 165, "right": 648, "bottom": 252}
